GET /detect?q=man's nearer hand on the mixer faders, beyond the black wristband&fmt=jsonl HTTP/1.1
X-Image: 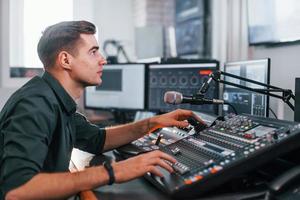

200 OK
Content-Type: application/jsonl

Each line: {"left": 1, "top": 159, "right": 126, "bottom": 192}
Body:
{"left": 112, "top": 151, "right": 176, "bottom": 183}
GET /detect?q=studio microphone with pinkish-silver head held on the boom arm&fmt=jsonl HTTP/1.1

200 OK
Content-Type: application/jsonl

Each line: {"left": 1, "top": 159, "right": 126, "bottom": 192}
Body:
{"left": 164, "top": 91, "right": 224, "bottom": 105}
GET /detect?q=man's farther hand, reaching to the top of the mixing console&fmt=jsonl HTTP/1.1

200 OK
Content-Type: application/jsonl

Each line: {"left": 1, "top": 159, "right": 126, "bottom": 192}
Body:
{"left": 149, "top": 109, "right": 205, "bottom": 132}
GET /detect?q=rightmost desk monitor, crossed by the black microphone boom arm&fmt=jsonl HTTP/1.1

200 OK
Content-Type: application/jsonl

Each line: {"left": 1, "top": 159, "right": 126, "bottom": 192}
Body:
{"left": 223, "top": 59, "right": 271, "bottom": 117}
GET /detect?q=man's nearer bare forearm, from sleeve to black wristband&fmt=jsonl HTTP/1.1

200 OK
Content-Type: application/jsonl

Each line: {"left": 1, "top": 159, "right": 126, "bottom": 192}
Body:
{"left": 5, "top": 166, "right": 109, "bottom": 200}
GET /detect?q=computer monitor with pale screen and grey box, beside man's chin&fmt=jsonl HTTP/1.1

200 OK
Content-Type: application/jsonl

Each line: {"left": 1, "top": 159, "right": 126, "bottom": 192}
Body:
{"left": 84, "top": 64, "right": 146, "bottom": 110}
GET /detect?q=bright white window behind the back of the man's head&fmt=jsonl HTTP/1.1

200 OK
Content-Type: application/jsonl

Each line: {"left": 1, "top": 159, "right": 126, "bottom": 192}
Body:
{"left": 9, "top": 0, "right": 73, "bottom": 70}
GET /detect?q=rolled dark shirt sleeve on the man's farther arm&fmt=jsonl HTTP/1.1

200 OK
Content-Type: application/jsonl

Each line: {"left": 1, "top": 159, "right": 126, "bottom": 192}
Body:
{"left": 74, "top": 112, "right": 106, "bottom": 155}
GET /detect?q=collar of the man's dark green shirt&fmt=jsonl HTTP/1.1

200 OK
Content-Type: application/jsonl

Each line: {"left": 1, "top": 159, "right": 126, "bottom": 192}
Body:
{"left": 42, "top": 71, "right": 77, "bottom": 115}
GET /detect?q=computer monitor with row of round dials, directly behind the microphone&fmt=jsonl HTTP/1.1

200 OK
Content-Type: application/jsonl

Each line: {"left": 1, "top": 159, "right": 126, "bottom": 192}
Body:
{"left": 148, "top": 60, "right": 219, "bottom": 114}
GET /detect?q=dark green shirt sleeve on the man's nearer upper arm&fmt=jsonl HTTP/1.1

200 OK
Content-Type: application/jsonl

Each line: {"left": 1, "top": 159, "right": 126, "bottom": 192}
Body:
{"left": 1, "top": 97, "right": 56, "bottom": 195}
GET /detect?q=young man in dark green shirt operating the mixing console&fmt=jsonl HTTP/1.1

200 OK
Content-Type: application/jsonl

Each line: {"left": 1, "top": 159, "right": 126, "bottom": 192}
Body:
{"left": 0, "top": 21, "right": 204, "bottom": 199}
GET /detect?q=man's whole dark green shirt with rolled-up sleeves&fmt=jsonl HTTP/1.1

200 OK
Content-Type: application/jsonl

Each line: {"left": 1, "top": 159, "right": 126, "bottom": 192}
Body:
{"left": 0, "top": 72, "right": 106, "bottom": 199}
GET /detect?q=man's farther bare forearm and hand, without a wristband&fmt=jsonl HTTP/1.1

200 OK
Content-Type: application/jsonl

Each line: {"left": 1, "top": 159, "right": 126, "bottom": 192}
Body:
{"left": 104, "top": 109, "right": 202, "bottom": 150}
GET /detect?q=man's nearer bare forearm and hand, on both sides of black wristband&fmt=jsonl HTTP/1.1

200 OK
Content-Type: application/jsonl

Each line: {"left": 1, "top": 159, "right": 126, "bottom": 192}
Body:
{"left": 5, "top": 151, "right": 176, "bottom": 200}
